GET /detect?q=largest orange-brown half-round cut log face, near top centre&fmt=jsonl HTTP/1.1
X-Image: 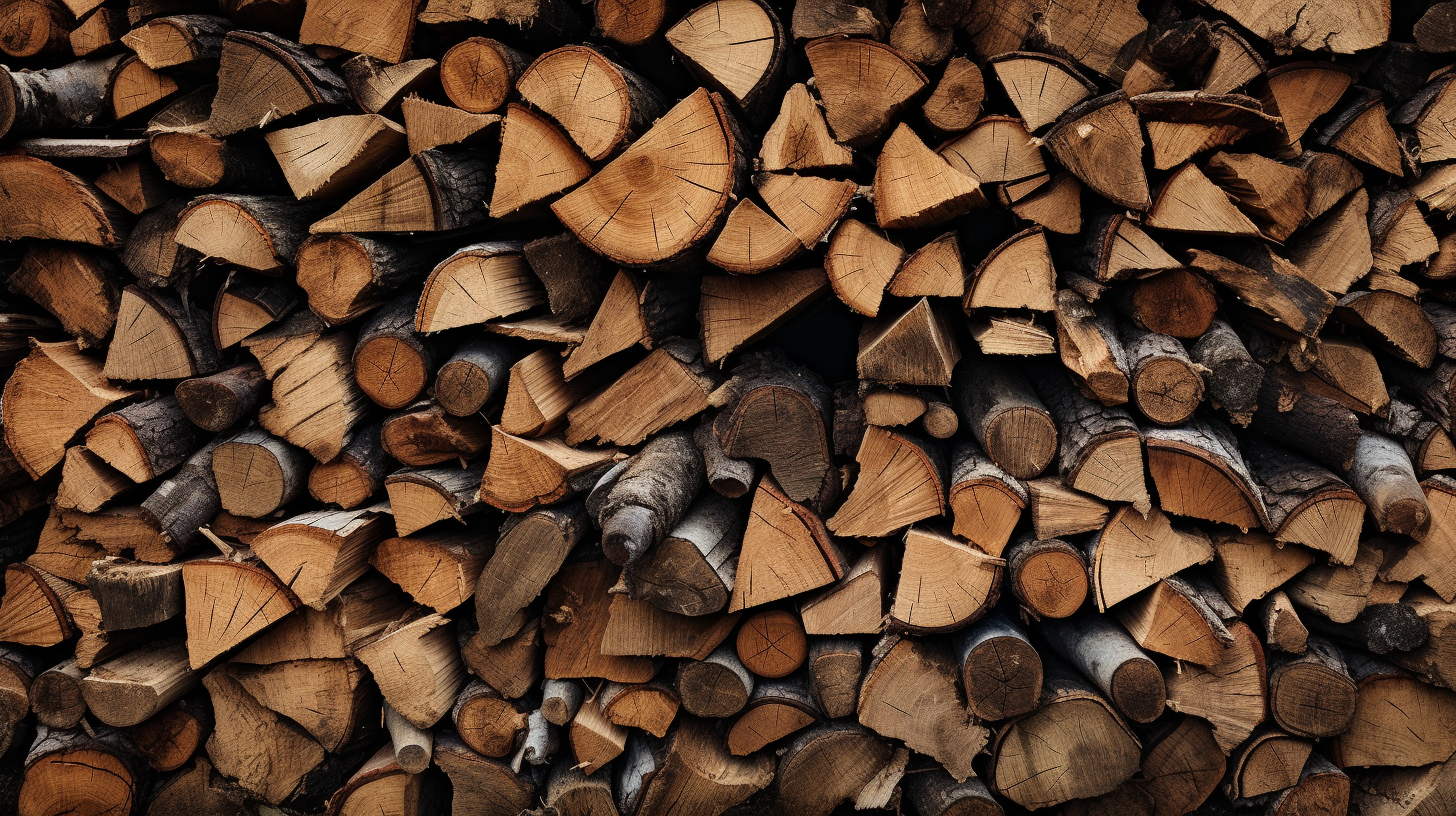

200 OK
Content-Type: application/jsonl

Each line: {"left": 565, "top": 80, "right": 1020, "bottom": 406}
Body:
{"left": 552, "top": 90, "right": 744, "bottom": 267}
